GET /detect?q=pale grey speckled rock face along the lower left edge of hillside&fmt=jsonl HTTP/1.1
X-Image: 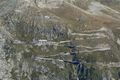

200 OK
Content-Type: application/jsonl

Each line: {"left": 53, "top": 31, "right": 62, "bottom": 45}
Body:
{"left": 0, "top": 27, "right": 14, "bottom": 80}
